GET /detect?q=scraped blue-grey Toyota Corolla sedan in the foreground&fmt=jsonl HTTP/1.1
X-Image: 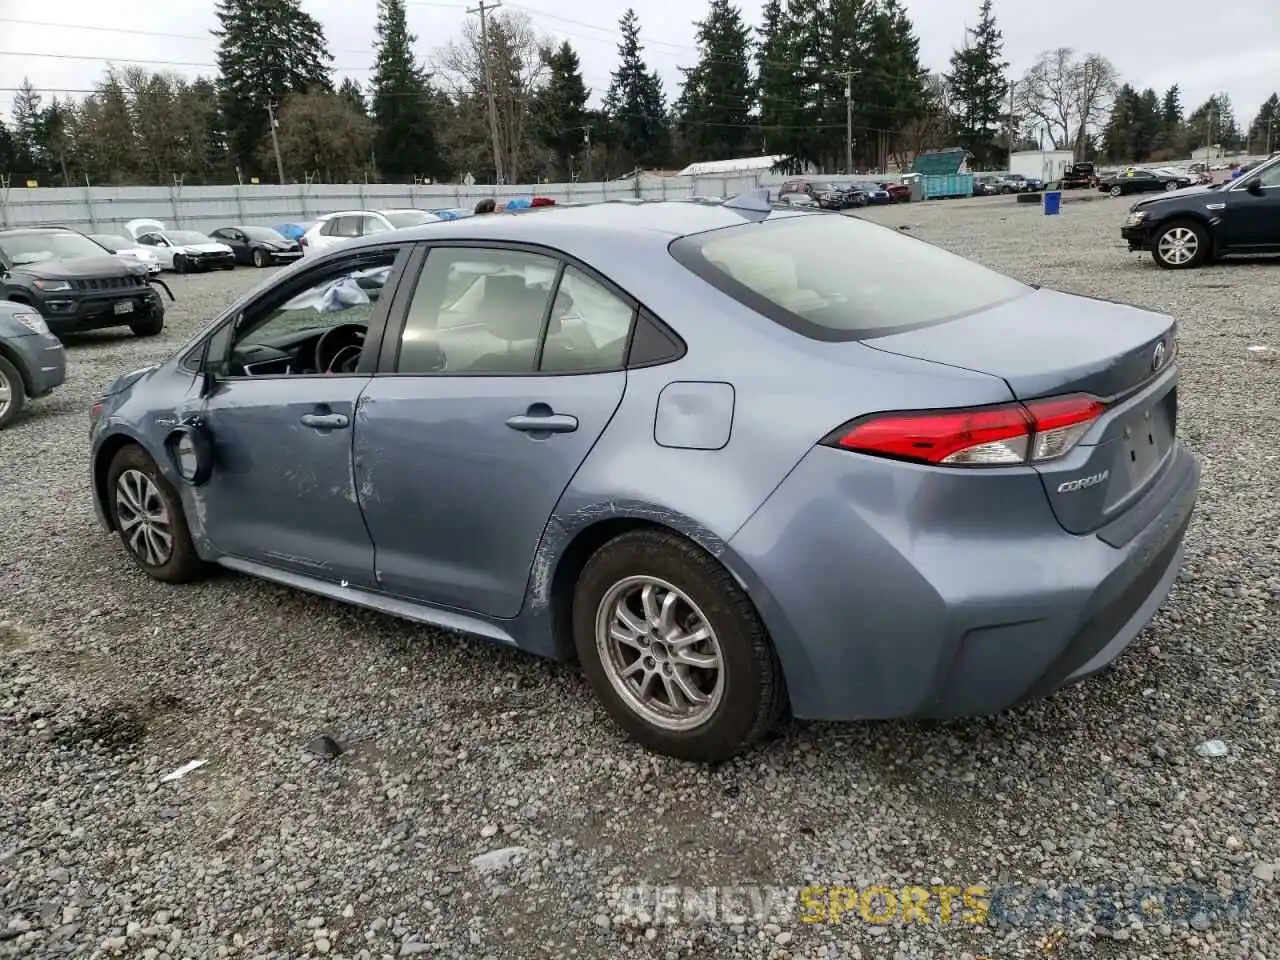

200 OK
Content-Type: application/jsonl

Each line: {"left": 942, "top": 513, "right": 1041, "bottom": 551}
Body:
{"left": 91, "top": 193, "right": 1199, "bottom": 762}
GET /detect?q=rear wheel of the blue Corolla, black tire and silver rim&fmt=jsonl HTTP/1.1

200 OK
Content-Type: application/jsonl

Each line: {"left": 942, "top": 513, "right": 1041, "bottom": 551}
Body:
{"left": 573, "top": 530, "right": 786, "bottom": 763}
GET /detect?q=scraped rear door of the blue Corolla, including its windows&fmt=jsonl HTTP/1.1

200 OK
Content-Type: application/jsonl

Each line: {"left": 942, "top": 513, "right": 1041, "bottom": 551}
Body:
{"left": 355, "top": 246, "right": 634, "bottom": 617}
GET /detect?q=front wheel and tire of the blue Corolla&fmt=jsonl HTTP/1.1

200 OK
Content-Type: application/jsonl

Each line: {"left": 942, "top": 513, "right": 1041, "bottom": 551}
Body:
{"left": 106, "top": 445, "right": 209, "bottom": 584}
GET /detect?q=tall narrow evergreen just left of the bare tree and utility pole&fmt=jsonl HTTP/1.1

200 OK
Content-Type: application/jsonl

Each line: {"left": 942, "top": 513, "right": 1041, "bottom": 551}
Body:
{"left": 370, "top": 0, "right": 444, "bottom": 182}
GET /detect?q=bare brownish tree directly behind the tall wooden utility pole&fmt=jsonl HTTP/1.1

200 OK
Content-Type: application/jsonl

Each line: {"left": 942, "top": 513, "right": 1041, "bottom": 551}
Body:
{"left": 435, "top": 13, "right": 552, "bottom": 183}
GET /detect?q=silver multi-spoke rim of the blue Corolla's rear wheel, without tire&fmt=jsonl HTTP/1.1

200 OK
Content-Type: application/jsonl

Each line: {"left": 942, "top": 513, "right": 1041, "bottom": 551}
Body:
{"left": 595, "top": 576, "right": 724, "bottom": 731}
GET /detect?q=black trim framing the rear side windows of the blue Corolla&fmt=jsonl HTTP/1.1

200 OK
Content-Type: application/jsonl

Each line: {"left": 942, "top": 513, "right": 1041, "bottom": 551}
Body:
{"left": 375, "top": 238, "right": 689, "bottom": 379}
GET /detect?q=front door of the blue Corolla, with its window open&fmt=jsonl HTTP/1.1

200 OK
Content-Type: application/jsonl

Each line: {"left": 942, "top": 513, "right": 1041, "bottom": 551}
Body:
{"left": 193, "top": 241, "right": 409, "bottom": 586}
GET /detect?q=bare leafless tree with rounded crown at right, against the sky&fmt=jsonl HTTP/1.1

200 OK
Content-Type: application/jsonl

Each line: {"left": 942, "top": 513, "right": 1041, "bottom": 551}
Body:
{"left": 1015, "top": 46, "right": 1119, "bottom": 155}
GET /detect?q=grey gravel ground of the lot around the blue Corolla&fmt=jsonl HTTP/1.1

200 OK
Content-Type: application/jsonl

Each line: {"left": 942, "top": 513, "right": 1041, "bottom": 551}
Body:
{"left": 0, "top": 198, "right": 1280, "bottom": 960}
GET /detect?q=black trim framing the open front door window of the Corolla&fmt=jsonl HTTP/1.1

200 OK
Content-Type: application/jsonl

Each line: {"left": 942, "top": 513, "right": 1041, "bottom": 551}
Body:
{"left": 182, "top": 242, "right": 413, "bottom": 383}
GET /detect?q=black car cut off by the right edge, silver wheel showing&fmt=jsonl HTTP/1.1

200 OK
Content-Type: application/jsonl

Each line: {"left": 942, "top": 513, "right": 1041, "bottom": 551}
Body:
{"left": 1120, "top": 154, "right": 1280, "bottom": 270}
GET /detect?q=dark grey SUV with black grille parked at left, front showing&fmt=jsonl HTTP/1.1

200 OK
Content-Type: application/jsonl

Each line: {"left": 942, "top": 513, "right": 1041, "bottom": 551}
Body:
{"left": 0, "top": 227, "right": 173, "bottom": 337}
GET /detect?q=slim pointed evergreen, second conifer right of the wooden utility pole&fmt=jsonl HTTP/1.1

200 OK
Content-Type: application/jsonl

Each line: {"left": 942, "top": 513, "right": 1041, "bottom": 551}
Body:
{"left": 604, "top": 8, "right": 671, "bottom": 166}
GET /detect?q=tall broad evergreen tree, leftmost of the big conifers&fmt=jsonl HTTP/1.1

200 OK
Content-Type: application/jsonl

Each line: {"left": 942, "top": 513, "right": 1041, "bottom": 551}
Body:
{"left": 212, "top": 0, "right": 333, "bottom": 179}
